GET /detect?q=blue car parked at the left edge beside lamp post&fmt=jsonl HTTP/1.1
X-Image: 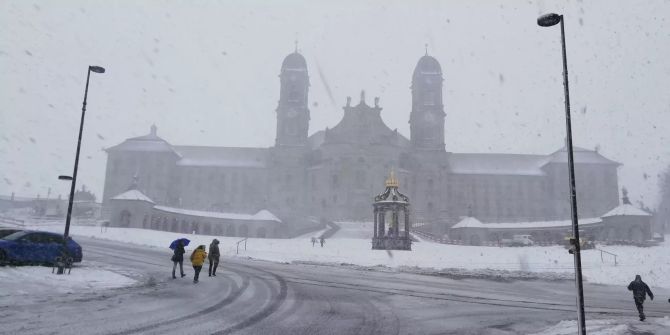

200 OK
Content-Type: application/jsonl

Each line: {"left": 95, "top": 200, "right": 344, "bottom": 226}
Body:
{"left": 0, "top": 230, "right": 82, "bottom": 264}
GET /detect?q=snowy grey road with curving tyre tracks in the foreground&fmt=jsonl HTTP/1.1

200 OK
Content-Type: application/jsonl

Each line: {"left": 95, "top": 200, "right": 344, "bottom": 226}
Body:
{"left": 0, "top": 238, "right": 670, "bottom": 334}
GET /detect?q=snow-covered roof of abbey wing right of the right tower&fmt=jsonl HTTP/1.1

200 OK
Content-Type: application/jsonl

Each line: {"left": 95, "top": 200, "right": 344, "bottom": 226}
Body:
{"left": 449, "top": 153, "right": 547, "bottom": 176}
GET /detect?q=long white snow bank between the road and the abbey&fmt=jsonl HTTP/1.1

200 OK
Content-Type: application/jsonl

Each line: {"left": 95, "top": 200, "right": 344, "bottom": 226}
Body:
{"left": 14, "top": 223, "right": 670, "bottom": 288}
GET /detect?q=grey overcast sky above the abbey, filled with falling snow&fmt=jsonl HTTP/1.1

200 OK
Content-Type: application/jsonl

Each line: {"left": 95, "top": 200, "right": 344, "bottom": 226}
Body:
{"left": 0, "top": 0, "right": 670, "bottom": 205}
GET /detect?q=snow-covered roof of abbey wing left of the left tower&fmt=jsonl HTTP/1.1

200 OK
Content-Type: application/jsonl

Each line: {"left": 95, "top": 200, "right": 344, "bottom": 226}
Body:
{"left": 174, "top": 146, "right": 268, "bottom": 168}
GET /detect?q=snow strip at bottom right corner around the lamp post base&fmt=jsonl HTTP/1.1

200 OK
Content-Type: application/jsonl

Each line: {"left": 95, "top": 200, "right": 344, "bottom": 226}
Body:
{"left": 533, "top": 316, "right": 670, "bottom": 335}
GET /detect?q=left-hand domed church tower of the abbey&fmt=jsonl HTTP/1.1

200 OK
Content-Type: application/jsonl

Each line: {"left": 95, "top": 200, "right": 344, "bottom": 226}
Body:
{"left": 275, "top": 48, "right": 309, "bottom": 147}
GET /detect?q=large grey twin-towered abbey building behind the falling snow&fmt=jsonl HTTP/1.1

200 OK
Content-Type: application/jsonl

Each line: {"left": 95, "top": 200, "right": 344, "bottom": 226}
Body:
{"left": 103, "top": 52, "right": 619, "bottom": 236}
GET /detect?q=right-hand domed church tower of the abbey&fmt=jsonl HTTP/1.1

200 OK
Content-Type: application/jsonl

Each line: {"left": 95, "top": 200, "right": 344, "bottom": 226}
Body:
{"left": 409, "top": 53, "right": 446, "bottom": 151}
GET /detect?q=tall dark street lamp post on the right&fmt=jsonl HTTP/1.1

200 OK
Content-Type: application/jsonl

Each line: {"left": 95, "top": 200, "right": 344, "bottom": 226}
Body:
{"left": 537, "top": 13, "right": 586, "bottom": 335}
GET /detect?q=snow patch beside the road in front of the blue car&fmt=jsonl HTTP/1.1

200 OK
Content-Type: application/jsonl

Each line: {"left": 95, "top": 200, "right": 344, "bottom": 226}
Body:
{"left": 0, "top": 261, "right": 137, "bottom": 302}
